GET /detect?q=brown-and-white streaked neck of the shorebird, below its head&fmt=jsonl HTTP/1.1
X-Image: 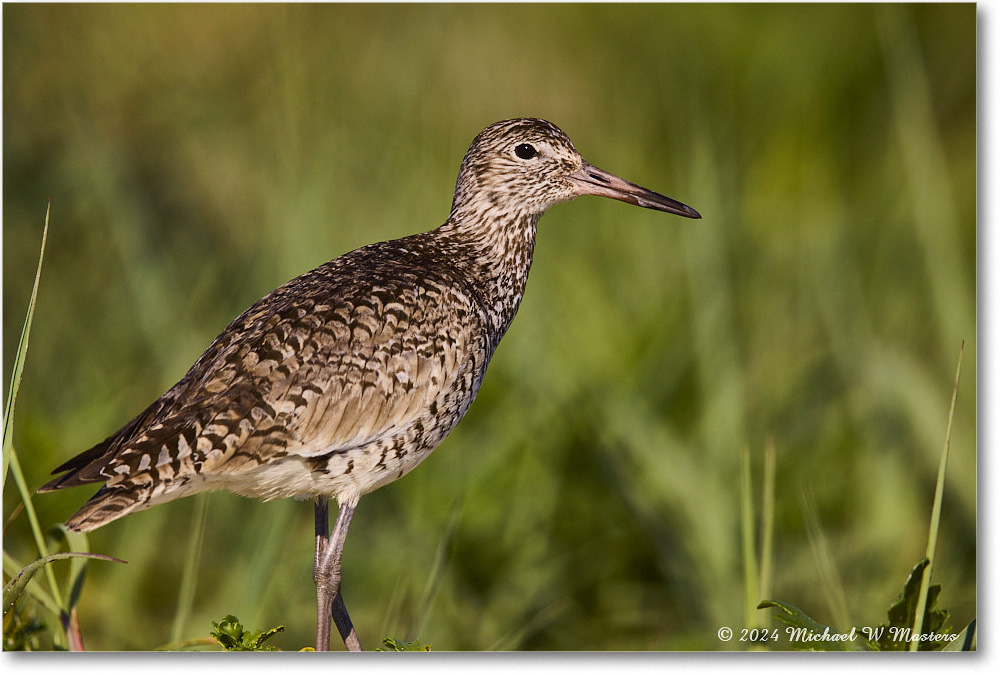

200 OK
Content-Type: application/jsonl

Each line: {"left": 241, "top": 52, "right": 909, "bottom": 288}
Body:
{"left": 438, "top": 204, "right": 539, "bottom": 335}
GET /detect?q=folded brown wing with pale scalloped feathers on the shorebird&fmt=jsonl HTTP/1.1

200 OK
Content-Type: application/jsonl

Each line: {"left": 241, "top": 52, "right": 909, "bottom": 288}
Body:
{"left": 41, "top": 252, "right": 479, "bottom": 501}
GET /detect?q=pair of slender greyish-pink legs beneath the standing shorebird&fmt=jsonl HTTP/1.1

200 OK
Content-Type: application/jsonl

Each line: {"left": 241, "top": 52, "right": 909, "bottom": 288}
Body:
{"left": 313, "top": 498, "right": 361, "bottom": 651}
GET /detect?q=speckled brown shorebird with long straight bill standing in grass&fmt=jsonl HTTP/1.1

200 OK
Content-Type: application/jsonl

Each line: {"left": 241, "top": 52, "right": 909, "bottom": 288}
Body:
{"left": 39, "top": 118, "right": 701, "bottom": 651}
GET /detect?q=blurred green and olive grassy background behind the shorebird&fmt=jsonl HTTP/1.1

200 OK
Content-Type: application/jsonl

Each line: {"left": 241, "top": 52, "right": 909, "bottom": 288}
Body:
{"left": 3, "top": 4, "right": 977, "bottom": 650}
